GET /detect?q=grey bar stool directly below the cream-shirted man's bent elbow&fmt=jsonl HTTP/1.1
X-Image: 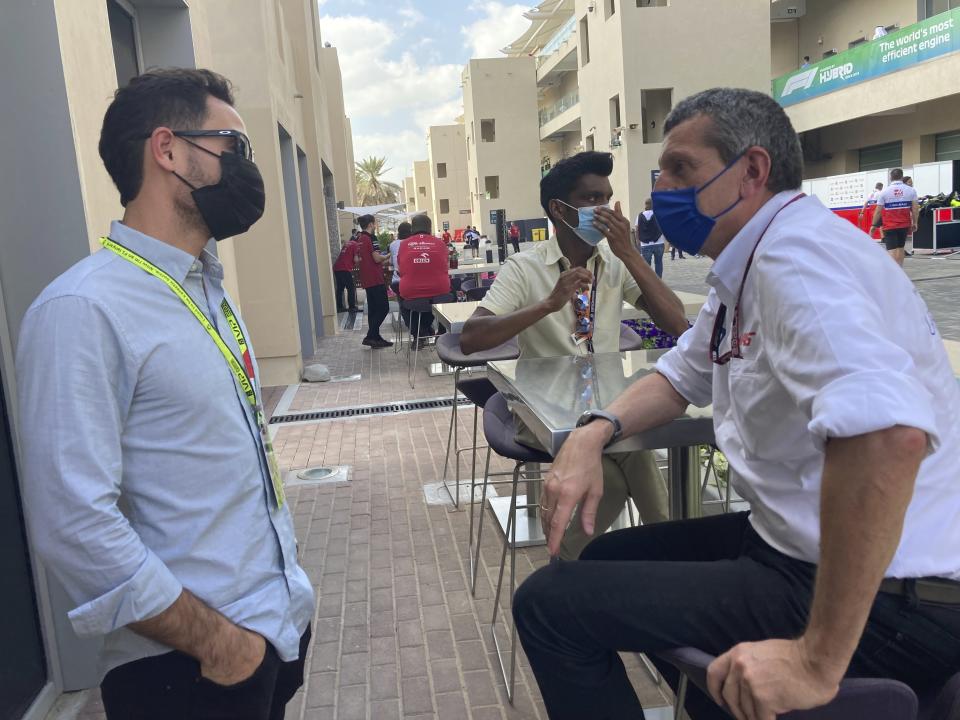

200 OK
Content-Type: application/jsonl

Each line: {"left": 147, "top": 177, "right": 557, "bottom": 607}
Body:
{"left": 437, "top": 333, "right": 520, "bottom": 510}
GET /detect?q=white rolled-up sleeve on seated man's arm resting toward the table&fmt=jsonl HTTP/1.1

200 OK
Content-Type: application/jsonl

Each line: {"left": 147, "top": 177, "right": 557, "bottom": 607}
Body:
{"left": 656, "top": 291, "right": 720, "bottom": 407}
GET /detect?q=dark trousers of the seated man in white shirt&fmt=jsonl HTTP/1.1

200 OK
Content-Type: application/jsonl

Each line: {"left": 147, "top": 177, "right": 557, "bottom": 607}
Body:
{"left": 513, "top": 513, "right": 960, "bottom": 720}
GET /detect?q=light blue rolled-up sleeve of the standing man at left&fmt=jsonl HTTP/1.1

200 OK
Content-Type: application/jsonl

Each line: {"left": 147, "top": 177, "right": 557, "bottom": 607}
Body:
{"left": 17, "top": 296, "right": 183, "bottom": 636}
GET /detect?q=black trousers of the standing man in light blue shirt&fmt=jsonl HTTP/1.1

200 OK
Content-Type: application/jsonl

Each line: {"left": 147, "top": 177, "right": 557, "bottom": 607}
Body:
{"left": 100, "top": 627, "right": 310, "bottom": 720}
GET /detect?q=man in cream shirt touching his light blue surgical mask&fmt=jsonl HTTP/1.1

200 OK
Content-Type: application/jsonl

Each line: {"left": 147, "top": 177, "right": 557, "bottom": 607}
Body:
{"left": 460, "top": 152, "right": 688, "bottom": 559}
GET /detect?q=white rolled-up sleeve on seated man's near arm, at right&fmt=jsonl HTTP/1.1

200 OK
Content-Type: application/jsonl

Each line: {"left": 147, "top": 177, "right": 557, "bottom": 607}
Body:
{"left": 757, "top": 238, "right": 940, "bottom": 450}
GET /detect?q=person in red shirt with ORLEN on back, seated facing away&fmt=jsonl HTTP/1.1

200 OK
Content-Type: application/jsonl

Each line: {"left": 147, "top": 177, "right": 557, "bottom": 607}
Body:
{"left": 397, "top": 215, "right": 450, "bottom": 346}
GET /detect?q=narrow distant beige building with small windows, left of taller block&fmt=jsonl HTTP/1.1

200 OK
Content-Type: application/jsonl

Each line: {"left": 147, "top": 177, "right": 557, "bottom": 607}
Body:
{"left": 427, "top": 123, "right": 471, "bottom": 235}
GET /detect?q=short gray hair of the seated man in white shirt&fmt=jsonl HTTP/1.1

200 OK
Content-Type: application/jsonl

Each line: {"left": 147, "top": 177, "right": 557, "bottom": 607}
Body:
{"left": 663, "top": 88, "right": 803, "bottom": 193}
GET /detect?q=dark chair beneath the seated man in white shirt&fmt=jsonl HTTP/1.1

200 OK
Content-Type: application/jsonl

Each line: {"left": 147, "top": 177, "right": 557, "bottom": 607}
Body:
{"left": 656, "top": 647, "right": 960, "bottom": 720}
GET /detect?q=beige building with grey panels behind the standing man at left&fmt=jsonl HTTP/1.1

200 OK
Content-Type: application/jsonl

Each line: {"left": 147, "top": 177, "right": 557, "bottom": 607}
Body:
{"left": 0, "top": 0, "right": 355, "bottom": 718}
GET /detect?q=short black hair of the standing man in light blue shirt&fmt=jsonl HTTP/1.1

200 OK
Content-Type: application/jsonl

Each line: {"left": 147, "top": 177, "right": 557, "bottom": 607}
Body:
{"left": 99, "top": 68, "right": 234, "bottom": 207}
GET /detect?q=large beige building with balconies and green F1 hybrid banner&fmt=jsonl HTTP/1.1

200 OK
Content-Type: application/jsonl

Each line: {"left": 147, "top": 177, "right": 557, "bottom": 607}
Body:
{"left": 502, "top": 0, "right": 960, "bottom": 218}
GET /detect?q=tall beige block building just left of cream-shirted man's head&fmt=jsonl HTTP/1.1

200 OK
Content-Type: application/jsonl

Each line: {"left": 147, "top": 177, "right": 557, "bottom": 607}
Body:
{"left": 462, "top": 56, "right": 543, "bottom": 236}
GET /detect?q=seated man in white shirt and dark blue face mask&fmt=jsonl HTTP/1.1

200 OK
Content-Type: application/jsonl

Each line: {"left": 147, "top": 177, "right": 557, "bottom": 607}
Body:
{"left": 513, "top": 89, "right": 960, "bottom": 720}
